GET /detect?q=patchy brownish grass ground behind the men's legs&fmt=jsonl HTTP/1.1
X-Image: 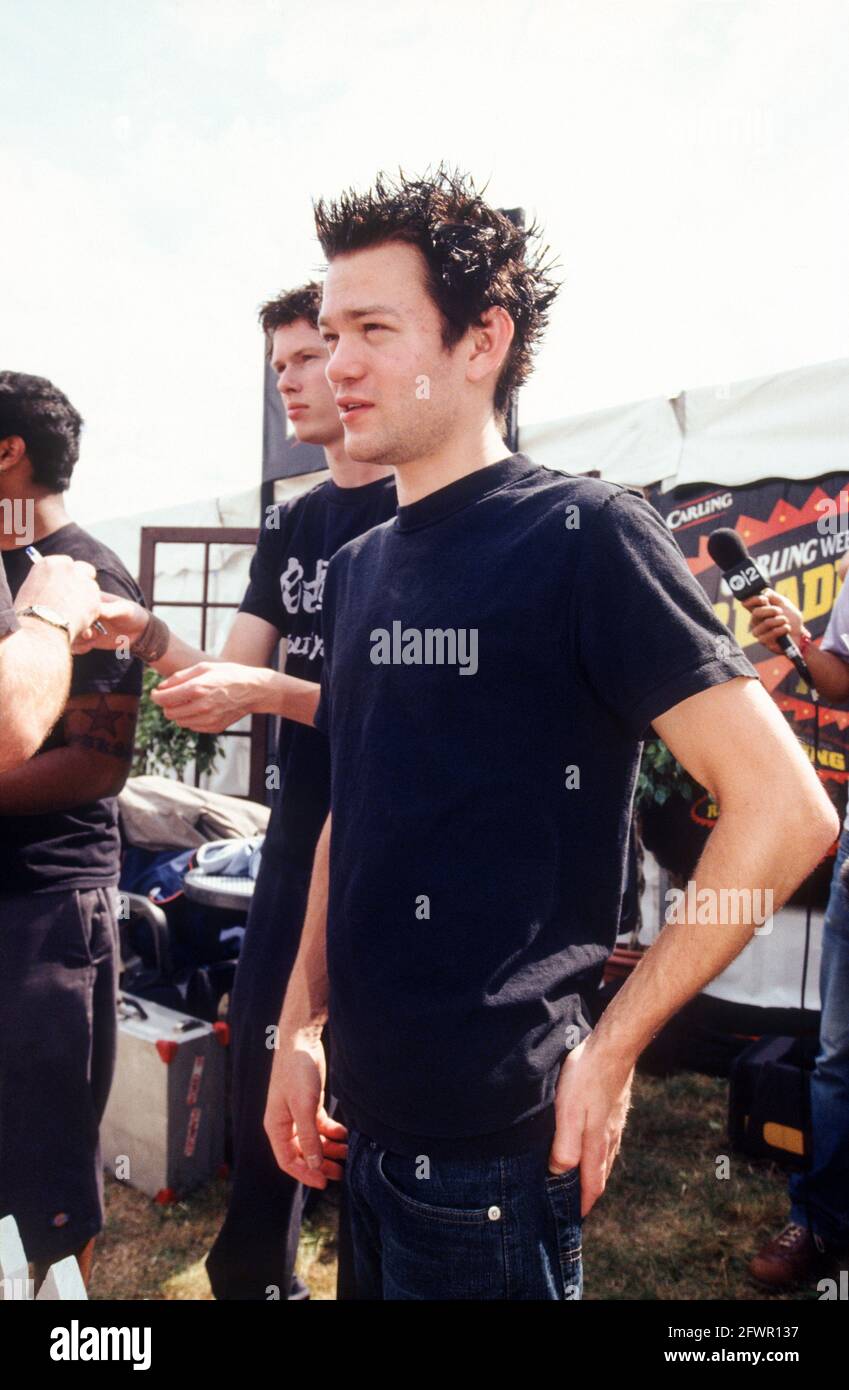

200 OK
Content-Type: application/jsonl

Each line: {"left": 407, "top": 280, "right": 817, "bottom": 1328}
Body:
{"left": 90, "top": 1073, "right": 817, "bottom": 1300}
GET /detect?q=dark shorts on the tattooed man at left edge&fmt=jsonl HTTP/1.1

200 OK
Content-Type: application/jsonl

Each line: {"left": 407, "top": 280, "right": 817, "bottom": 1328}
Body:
{"left": 0, "top": 887, "right": 119, "bottom": 1261}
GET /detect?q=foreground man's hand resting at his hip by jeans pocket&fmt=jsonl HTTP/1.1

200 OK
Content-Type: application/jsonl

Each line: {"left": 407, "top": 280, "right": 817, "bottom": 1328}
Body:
{"left": 549, "top": 1036, "right": 634, "bottom": 1216}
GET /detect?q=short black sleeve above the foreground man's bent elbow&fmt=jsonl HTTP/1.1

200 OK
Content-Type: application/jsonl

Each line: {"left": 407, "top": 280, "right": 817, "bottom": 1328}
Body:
{"left": 574, "top": 492, "right": 757, "bottom": 738}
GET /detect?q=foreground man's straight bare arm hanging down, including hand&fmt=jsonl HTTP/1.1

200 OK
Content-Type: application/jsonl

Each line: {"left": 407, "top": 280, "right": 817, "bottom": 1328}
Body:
{"left": 264, "top": 816, "right": 347, "bottom": 1187}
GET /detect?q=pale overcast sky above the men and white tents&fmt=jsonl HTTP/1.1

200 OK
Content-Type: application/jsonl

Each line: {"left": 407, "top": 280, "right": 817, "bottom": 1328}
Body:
{"left": 0, "top": 0, "right": 849, "bottom": 521}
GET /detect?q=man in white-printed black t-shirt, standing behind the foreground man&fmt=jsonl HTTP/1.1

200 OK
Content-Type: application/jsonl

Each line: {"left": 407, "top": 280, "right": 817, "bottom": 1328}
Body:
{"left": 81, "top": 281, "right": 396, "bottom": 1301}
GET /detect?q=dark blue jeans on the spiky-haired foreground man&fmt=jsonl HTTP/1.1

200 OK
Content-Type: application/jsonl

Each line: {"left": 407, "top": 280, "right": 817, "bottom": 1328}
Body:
{"left": 345, "top": 1129, "right": 582, "bottom": 1301}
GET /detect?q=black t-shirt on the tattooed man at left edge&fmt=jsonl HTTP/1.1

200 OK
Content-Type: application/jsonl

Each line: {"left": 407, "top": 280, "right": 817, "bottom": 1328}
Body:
{"left": 0, "top": 521, "right": 145, "bottom": 894}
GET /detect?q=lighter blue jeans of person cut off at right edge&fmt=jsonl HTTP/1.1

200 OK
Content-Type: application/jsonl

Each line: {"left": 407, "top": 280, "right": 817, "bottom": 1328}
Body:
{"left": 789, "top": 830, "right": 849, "bottom": 1247}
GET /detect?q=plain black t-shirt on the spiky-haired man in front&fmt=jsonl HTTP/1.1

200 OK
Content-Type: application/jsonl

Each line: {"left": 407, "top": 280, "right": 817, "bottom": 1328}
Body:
{"left": 315, "top": 455, "right": 757, "bottom": 1156}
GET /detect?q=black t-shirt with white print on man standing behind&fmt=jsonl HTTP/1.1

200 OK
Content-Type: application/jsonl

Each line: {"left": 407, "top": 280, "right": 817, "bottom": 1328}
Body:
{"left": 240, "top": 477, "right": 396, "bottom": 867}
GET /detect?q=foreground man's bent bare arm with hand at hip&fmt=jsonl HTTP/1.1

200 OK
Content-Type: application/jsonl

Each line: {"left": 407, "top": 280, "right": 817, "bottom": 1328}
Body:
{"left": 550, "top": 677, "right": 839, "bottom": 1212}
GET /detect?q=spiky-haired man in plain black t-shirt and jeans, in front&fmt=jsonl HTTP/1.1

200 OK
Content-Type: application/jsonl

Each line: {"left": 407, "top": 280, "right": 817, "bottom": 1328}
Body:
{"left": 265, "top": 170, "right": 838, "bottom": 1300}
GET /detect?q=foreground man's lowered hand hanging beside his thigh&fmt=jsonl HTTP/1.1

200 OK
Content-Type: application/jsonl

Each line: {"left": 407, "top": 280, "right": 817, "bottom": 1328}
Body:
{"left": 263, "top": 1029, "right": 347, "bottom": 1187}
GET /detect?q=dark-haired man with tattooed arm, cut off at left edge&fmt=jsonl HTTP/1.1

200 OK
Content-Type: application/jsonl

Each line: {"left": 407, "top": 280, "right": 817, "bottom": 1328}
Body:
{"left": 0, "top": 371, "right": 142, "bottom": 1283}
